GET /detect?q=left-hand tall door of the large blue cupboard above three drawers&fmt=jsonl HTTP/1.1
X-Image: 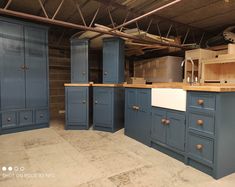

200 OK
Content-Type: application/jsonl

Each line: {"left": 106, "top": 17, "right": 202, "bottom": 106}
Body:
{"left": 0, "top": 21, "right": 25, "bottom": 110}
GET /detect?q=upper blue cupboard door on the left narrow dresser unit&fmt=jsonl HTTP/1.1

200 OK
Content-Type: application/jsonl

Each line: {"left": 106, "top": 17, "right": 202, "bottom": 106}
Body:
{"left": 71, "top": 39, "right": 89, "bottom": 83}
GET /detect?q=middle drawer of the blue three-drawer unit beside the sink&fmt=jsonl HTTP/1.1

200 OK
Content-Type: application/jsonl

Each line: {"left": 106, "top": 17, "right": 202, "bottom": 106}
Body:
{"left": 189, "top": 112, "right": 215, "bottom": 135}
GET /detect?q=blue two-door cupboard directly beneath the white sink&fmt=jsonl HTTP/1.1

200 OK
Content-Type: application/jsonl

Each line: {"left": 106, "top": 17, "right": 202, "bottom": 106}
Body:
{"left": 151, "top": 107, "right": 186, "bottom": 156}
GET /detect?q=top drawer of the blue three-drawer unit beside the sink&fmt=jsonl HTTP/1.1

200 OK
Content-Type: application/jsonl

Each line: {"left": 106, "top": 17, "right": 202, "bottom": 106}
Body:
{"left": 188, "top": 92, "right": 216, "bottom": 110}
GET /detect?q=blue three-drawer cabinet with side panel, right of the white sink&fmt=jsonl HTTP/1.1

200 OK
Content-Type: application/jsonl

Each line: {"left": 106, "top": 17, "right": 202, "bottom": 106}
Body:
{"left": 186, "top": 91, "right": 235, "bottom": 179}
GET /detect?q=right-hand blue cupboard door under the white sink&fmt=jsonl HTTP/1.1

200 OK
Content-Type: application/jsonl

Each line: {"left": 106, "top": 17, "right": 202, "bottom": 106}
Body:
{"left": 167, "top": 111, "right": 186, "bottom": 151}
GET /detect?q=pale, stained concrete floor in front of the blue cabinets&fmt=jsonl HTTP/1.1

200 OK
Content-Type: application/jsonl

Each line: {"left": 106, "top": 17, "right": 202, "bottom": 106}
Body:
{"left": 0, "top": 122, "right": 235, "bottom": 187}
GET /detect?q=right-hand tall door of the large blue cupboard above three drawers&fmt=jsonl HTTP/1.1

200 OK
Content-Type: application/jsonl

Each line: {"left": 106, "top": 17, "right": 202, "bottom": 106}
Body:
{"left": 25, "top": 27, "right": 48, "bottom": 108}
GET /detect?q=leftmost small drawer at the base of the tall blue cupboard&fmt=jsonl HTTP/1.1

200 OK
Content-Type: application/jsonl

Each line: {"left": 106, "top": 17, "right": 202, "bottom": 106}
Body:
{"left": 2, "top": 112, "right": 17, "bottom": 129}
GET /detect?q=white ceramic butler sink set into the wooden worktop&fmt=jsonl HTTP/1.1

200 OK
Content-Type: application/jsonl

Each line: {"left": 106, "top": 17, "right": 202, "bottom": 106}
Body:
{"left": 151, "top": 88, "right": 186, "bottom": 111}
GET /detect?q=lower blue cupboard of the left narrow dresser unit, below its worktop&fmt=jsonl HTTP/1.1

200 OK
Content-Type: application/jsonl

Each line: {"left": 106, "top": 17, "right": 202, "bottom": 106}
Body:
{"left": 65, "top": 86, "right": 89, "bottom": 130}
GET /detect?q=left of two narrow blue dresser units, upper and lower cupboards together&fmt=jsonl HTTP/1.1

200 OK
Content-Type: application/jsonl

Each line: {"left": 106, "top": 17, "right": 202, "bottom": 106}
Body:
{"left": 65, "top": 38, "right": 92, "bottom": 130}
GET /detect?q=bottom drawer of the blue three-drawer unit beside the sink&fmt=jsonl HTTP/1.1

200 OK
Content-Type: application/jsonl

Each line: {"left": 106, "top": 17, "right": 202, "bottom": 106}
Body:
{"left": 188, "top": 133, "right": 214, "bottom": 165}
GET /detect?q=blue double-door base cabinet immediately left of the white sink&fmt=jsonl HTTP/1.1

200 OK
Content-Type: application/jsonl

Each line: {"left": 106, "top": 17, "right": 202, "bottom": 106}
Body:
{"left": 125, "top": 88, "right": 151, "bottom": 145}
